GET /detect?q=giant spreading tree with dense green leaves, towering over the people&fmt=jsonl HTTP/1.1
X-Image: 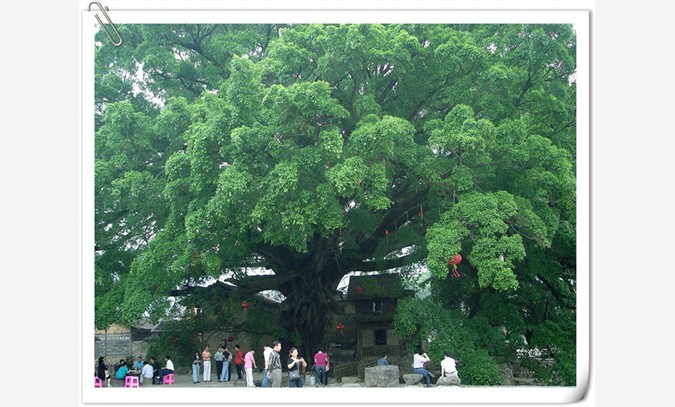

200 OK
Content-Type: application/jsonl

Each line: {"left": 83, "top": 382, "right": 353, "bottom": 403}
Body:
{"left": 95, "top": 24, "right": 576, "bottom": 364}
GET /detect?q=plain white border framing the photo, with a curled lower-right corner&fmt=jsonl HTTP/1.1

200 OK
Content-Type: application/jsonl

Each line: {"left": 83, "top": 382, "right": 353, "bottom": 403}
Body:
{"left": 80, "top": 10, "right": 591, "bottom": 404}
